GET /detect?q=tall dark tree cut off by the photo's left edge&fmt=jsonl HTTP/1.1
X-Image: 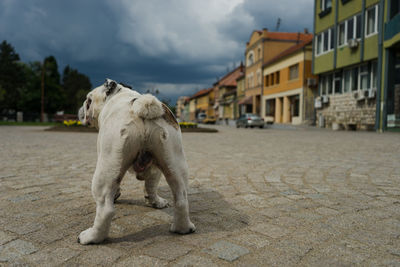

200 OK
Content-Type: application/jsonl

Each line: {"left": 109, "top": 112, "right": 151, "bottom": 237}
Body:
{"left": 0, "top": 40, "right": 25, "bottom": 109}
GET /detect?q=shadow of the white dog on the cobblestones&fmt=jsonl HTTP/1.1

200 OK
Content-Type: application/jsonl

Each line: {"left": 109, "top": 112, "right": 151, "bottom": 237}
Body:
{"left": 106, "top": 186, "right": 249, "bottom": 243}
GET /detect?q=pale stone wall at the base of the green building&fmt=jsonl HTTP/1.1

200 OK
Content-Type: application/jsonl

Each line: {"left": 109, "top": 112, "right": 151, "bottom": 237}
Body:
{"left": 316, "top": 93, "right": 376, "bottom": 130}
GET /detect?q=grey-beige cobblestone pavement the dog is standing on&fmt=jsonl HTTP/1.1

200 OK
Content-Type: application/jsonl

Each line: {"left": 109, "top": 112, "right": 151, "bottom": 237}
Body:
{"left": 0, "top": 126, "right": 400, "bottom": 266}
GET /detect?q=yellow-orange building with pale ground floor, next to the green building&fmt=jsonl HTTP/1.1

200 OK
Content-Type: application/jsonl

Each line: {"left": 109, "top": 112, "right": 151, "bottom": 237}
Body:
{"left": 261, "top": 36, "right": 317, "bottom": 124}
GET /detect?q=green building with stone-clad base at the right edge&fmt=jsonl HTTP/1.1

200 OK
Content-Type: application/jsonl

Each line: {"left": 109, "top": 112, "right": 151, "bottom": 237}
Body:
{"left": 313, "top": 0, "right": 400, "bottom": 131}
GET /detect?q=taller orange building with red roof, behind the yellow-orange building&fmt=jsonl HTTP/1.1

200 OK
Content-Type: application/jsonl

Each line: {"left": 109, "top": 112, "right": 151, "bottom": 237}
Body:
{"left": 241, "top": 29, "right": 312, "bottom": 114}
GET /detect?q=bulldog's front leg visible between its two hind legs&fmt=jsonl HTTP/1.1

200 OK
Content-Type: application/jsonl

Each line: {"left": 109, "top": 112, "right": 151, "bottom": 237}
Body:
{"left": 137, "top": 165, "right": 168, "bottom": 209}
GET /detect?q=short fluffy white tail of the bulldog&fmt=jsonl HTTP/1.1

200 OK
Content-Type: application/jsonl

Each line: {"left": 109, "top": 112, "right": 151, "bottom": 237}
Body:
{"left": 132, "top": 94, "right": 164, "bottom": 120}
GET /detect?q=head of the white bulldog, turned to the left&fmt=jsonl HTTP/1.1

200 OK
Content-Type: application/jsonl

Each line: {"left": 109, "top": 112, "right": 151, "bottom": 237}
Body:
{"left": 78, "top": 79, "right": 121, "bottom": 128}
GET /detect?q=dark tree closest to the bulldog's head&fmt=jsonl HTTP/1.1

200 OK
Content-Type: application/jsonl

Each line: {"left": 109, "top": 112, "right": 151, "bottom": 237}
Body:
{"left": 62, "top": 66, "right": 92, "bottom": 113}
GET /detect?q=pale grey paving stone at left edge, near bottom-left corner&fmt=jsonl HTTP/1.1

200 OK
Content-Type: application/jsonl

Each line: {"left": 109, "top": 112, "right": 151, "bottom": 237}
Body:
{"left": 0, "top": 239, "right": 38, "bottom": 263}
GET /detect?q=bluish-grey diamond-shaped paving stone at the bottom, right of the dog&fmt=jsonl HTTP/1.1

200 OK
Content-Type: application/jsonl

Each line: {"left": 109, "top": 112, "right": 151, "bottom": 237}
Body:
{"left": 204, "top": 241, "right": 250, "bottom": 262}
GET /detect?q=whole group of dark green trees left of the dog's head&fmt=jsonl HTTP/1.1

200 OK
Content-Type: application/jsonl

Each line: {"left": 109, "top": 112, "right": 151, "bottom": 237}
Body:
{"left": 0, "top": 41, "right": 92, "bottom": 119}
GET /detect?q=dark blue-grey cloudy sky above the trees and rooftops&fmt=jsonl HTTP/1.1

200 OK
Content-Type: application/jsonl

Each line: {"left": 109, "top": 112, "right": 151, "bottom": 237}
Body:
{"left": 0, "top": 0, "right": 314, "bottom": 102}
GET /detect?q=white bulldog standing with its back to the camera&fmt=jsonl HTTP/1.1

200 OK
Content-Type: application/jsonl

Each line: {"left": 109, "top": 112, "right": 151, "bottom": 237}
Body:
{"left": 78, "top": 79, "right": 195, "bottom": 245}
